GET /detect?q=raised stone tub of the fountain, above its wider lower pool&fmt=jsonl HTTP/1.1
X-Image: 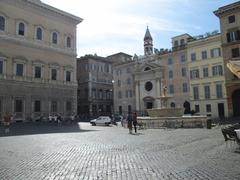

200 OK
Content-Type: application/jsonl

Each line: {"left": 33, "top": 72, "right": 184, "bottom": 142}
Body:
{"left": 147, "top": 108, "right": 184, "bottom": 117}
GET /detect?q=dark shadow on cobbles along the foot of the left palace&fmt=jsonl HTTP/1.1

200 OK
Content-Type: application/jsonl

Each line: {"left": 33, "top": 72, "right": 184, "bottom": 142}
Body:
{"left": 0, "top": 122, "right": 95, "bottom": 137}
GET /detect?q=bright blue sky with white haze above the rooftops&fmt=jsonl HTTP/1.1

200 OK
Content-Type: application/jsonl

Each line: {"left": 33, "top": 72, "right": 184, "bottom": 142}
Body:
{"left": 41, "top": 0, "right": 236, "bottom": 57}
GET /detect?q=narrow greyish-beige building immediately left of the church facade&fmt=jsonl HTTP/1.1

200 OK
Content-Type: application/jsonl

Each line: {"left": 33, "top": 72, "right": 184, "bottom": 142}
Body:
{"left": 107, "top": 52, "right": 136, "bottom": 116}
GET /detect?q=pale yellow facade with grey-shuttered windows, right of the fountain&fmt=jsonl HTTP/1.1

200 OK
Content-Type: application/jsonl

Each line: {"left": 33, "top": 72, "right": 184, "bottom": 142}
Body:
{"left": 187, "top": 33, "right": 228, "bottom": 118}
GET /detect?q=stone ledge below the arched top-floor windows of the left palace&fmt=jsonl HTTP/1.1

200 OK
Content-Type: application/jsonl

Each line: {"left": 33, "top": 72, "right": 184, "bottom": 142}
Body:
{"left": 0, "top": 35, "right": 77, "bottom": 58}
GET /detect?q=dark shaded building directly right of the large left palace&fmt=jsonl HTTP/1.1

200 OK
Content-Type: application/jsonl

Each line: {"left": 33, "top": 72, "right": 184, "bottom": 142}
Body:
{"left": 77, "top": 55, "right": 113, "bottom": 119}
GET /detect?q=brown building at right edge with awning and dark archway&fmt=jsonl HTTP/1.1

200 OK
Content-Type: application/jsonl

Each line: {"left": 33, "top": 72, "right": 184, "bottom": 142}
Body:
{"left": 214, "top": 1, "right": 240, "bottom": 117}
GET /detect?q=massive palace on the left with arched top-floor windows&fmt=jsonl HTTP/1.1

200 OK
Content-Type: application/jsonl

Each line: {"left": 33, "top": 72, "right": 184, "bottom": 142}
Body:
{"left": 0, "top": 0, "right": 82, "bottom": 121}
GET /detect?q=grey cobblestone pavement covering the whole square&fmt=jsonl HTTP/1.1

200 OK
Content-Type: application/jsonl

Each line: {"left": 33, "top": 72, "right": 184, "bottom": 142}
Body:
{"left": 0, "top": 123, "right": 240, "bottom": 180}
